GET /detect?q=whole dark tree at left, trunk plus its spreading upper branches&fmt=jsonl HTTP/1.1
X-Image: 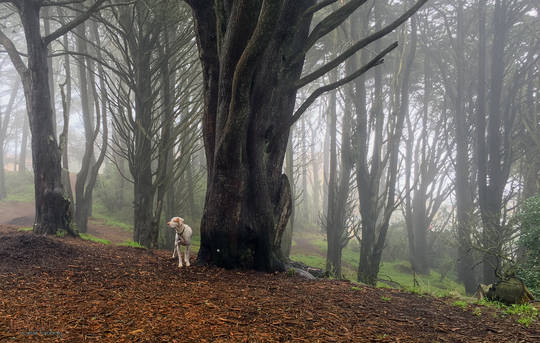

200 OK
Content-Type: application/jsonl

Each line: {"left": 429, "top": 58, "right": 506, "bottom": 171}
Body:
{"left": 0, "top": 0, "right": 105, "bottom": 234}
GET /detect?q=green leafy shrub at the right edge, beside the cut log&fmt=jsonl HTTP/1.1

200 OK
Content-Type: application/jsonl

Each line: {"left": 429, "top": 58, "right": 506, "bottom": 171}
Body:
{"left": 516, "top": 196, "right": 540, "bottom": 297}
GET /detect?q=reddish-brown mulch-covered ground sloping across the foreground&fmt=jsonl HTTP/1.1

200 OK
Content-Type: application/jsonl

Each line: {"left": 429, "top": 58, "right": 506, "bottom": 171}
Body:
{"left": 0, "top": 226, "right": 540, "bottom": 342}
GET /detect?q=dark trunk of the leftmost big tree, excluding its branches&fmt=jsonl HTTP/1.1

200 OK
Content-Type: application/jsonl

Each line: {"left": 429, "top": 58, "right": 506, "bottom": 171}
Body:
{"left": 20, "top": 1, "right": 72, "bottom": 234}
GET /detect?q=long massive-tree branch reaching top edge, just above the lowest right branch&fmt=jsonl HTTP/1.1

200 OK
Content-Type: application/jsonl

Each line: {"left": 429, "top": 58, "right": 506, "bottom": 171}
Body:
{"left": 295, "top": 0, "right": 428, "bottom": 89}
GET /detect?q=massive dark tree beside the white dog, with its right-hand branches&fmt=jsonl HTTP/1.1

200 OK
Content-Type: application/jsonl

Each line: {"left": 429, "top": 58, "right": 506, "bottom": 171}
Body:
{"left": 186, "top": 0, "right": 427, "bottom": 270}
